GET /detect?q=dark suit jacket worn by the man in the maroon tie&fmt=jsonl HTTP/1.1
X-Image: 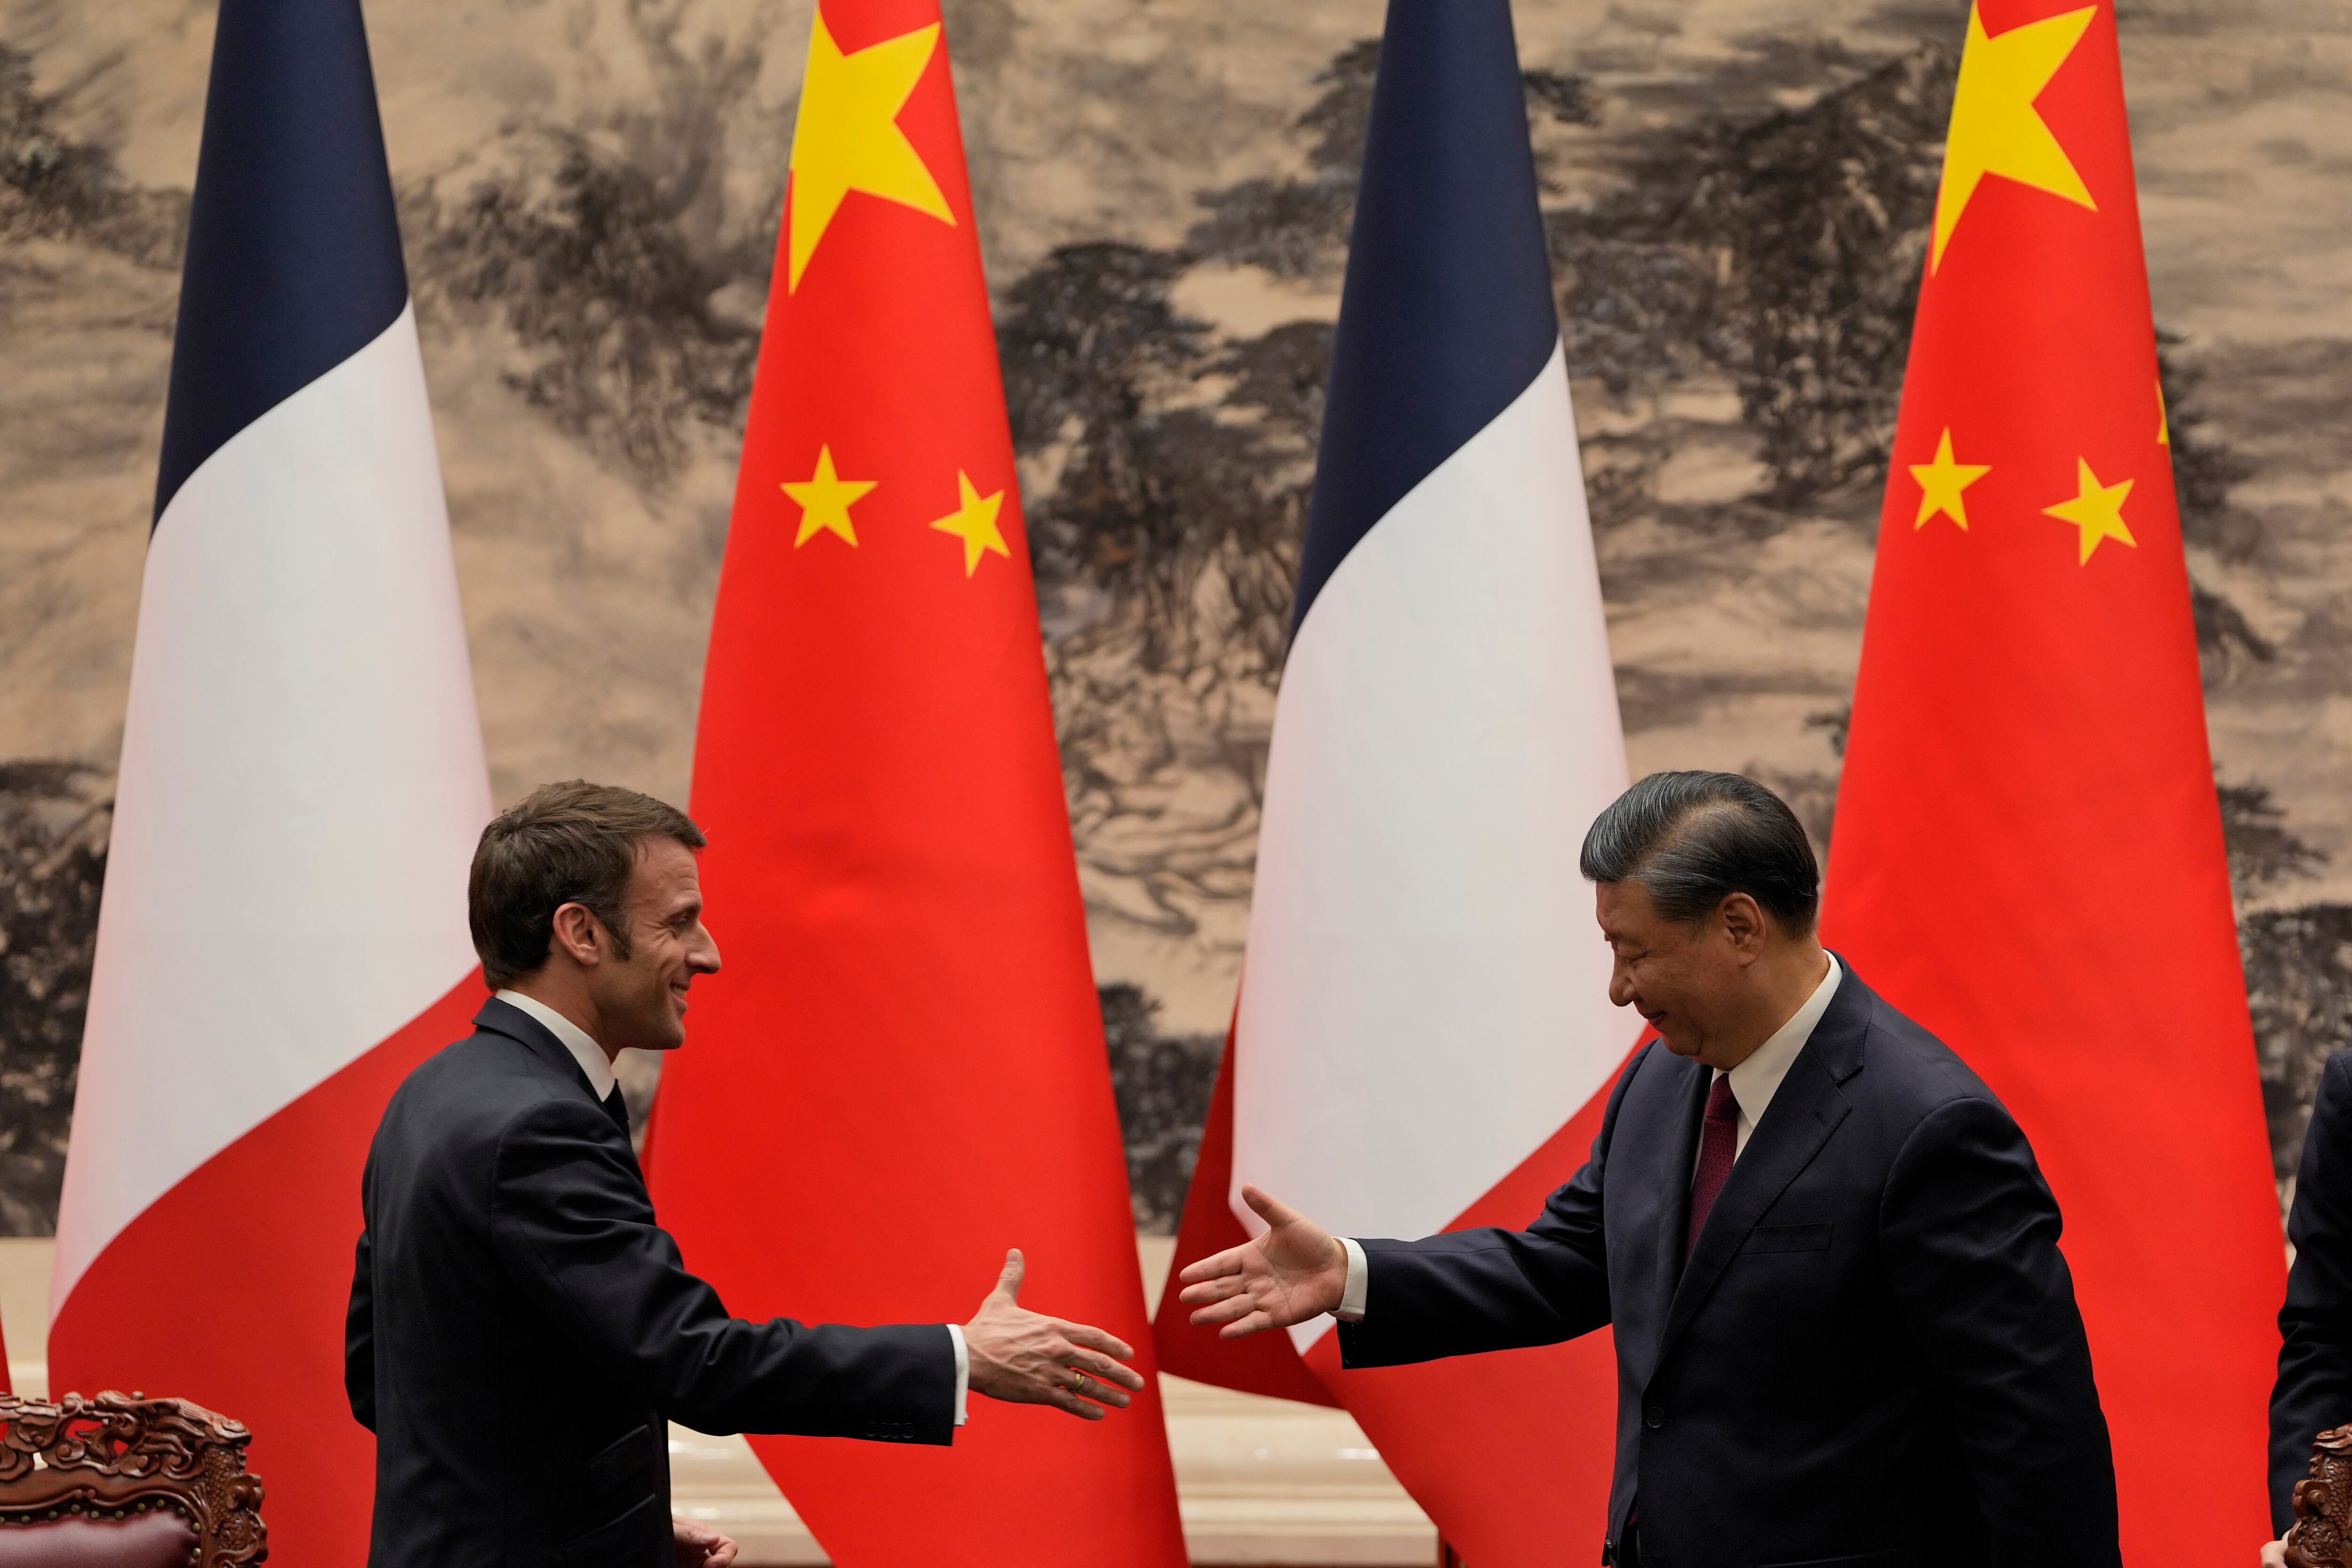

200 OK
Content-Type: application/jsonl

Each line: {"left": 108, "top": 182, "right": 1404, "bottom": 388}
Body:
{"left": 1338, "top": 969, "right": 2122, "bottom": 1568}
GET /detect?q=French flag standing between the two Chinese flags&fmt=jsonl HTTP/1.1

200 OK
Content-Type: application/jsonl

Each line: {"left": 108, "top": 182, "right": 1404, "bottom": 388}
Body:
{"left": 1155, "top": 0, "right": 1639, "bottom": 1568}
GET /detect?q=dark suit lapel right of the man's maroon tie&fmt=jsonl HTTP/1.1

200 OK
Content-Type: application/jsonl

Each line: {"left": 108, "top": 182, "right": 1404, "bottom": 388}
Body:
{"left": 1658, "top": 959, "right": 1870, "bottom": 1359}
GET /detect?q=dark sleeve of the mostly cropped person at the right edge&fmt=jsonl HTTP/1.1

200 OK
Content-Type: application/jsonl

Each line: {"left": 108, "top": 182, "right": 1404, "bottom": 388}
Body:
{"left": 2270, "top": 1051, "right": 2352, "bottom": 1535}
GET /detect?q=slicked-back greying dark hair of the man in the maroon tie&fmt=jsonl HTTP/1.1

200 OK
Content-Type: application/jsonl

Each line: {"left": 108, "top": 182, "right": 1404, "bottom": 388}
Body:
{"left": 1581, "top": 771, "right": 1820, "bottom": 936}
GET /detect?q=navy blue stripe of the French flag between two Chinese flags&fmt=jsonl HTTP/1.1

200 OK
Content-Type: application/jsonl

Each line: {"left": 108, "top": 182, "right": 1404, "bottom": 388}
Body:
{"left": 1291, "top": 0, "right": 1559, "bottom": 637}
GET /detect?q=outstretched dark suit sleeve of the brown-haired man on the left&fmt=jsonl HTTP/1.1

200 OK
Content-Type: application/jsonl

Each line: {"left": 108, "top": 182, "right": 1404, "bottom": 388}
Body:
{"left": 489, "top": 1100, "right": 955, "bottom": 1443}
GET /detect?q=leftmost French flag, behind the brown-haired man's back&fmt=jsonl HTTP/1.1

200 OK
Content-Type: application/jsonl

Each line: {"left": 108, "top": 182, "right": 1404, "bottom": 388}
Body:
{"left": 49, "top": 0, "right": 489, "bottom": 1566}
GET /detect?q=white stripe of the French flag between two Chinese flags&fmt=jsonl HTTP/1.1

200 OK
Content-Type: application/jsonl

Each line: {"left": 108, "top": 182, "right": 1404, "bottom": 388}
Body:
{"left": 1232, "top": 348, "right": 1632, "bottom": 1349}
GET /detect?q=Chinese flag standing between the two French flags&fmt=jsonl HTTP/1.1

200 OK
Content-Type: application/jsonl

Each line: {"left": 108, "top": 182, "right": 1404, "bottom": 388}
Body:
{"left": 652, "top": 0, "right": 1185, "bottom": 1568}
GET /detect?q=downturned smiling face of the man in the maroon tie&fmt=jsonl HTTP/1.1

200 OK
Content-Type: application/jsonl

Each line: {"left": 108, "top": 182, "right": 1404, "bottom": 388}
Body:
{"left": 1595, "top": 882, "right": 1762, "bottom": 1070}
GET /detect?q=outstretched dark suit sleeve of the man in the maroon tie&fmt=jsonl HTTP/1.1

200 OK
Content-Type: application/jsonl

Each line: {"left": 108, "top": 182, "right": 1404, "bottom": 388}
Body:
{"left": 1338, "top": 1046, "right": 1656, "bottom": 1366}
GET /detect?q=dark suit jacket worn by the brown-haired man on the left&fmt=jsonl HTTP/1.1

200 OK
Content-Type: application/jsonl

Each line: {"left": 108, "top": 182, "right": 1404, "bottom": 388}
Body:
{"left": 343, "top": 999, "right": 955, "bottom": 1568}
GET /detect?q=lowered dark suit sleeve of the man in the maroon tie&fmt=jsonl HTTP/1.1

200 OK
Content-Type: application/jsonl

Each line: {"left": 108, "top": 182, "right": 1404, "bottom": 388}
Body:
{"left": 1879, "top": 1098, "right": 2119, "bottom": 1568}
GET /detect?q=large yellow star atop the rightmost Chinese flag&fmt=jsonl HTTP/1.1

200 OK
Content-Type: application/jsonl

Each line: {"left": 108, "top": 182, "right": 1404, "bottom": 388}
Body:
{"left": 1926, "top": 5, "right": 2098, "bottom": 273}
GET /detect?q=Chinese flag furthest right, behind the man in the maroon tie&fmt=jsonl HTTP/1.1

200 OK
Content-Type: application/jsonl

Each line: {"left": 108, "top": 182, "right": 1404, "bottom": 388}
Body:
{"left": 1825, "top": 0, "right": 2286, "bottom": 1568}
